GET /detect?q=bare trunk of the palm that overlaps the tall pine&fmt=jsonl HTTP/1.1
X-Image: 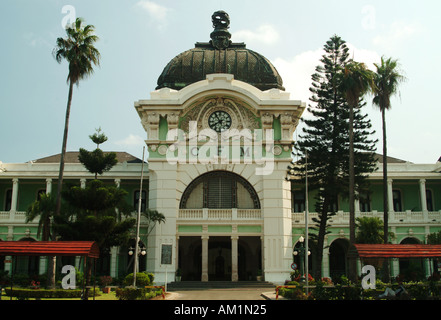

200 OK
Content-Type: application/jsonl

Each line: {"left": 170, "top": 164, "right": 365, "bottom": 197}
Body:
{"left": 348, "top": 104, "right": 357, "bottom": 282}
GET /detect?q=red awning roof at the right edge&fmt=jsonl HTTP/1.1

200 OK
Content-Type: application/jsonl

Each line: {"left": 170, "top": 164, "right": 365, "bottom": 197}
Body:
{"left": 355, "top": 244, "right": 441, "bottom": 258}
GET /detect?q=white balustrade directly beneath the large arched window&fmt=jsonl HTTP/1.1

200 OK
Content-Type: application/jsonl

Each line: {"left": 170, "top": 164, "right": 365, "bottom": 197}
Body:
{"left": 178, "top": 208, "right": 262, "bottom": 220}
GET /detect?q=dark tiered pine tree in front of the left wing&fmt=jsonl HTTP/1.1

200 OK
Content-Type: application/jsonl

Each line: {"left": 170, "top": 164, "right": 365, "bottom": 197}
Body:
{"left": 53, "top": 129, "right": 136, "bottom": 299}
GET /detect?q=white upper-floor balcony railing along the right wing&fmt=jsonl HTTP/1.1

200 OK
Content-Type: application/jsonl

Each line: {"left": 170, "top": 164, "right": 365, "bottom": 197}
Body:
{"left": 292, "top": 210, "right": 441, "bottom": 225}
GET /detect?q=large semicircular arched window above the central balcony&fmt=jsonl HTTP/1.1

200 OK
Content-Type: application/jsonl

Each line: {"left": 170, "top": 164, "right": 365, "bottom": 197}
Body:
{"left": 180, "top": 171, "right": 260, "bottom": 209}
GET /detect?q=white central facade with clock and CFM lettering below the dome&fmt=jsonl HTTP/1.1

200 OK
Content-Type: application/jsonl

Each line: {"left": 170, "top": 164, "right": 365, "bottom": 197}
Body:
{"left": 135, "top": 74, "right": 305, "bottom": 283}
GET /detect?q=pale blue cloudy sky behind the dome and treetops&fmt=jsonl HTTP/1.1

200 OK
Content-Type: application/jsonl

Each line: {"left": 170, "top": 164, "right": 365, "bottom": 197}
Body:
{"left": 0, "top": 0, "right": 441, "bottom": 163}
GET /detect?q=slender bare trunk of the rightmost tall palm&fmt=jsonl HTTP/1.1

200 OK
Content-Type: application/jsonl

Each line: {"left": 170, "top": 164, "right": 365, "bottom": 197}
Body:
{"left": 381, "top": 108, "right": 390, "bottom": 283}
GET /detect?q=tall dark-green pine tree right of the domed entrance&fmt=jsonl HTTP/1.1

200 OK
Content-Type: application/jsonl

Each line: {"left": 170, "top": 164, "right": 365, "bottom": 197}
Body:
{"left": 292, "top": 36, "right": 376, "bottom": 278}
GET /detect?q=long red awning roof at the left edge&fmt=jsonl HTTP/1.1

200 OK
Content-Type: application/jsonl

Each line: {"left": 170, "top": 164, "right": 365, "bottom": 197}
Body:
{"left": 0, "top": 241, "right": 100, "bottom": 258}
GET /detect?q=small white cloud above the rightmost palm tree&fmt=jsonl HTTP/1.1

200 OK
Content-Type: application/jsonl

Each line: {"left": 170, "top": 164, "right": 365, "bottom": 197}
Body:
{"left": 372, "top": 21, "right": 423, "bottom": 50}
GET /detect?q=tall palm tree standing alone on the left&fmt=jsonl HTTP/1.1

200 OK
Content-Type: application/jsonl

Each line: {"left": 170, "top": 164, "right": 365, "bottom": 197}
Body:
{"left": 53, "top": 18, "right": 100, "bottom": 215}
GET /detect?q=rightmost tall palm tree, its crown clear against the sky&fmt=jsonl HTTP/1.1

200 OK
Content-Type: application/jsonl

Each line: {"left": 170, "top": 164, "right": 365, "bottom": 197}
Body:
{"left": 372, "top": 57, "right": 406, "bottom": 282}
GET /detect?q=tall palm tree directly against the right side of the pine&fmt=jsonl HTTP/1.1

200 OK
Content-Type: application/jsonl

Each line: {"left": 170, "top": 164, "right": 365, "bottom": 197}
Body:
{"left": 340, "top": 61, "right": 374, "bottom": 281}
